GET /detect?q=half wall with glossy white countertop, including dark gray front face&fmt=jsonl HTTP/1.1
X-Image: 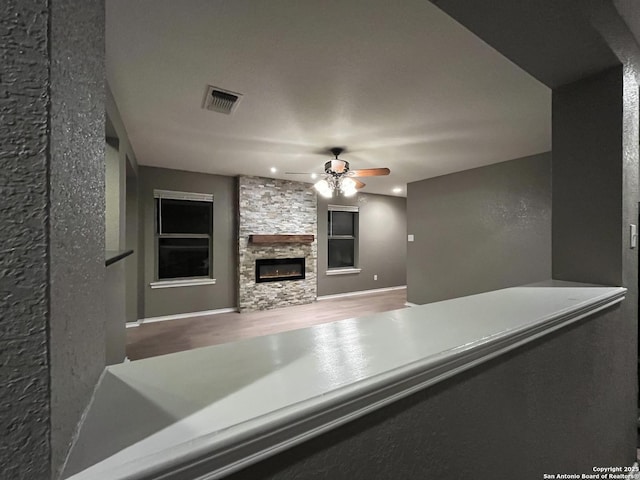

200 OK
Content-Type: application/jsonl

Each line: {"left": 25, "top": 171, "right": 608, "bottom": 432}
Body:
{"left": 66, "top": 281, "right": 635, "bottom": 480}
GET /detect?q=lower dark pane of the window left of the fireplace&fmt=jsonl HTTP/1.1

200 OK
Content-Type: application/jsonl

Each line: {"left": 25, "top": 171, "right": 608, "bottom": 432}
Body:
{"left": 158, "top": 238, "right": 210, "bottom": 279}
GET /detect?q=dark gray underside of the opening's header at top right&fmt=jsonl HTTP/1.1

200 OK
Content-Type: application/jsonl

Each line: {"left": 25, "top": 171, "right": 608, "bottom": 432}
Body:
{"left": 430, "top": 0, "right": 633, "bottom": 88}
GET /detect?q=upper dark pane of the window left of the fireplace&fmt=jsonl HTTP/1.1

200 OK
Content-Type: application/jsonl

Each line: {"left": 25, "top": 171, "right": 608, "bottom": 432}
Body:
{"left": 160, "top": 198, "right": 213, "bottom": 235}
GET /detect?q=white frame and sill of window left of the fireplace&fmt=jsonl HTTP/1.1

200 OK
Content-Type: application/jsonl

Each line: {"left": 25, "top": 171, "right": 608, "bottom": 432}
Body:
{"left": 150, "top": 190, "right": 216, "bottom": 288}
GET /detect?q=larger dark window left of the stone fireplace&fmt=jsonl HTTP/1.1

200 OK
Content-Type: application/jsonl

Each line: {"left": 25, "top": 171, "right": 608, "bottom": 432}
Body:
{"left": 154, "top": 190, "right": 213, "bottom": 280}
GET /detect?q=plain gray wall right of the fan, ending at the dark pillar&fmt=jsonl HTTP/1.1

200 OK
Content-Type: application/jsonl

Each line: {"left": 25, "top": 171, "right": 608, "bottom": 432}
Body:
{"left": 407, "top": 153, "right": 551, "bottom": 304}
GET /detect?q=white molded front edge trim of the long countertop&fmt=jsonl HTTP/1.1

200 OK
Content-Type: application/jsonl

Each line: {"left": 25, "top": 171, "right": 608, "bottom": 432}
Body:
{"left": 104, "top": 287, "right": 627, "bottom": 480}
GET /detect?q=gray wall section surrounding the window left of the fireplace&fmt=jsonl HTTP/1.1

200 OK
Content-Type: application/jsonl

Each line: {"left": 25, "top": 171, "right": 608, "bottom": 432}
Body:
{"left": 138, "top": 167, "right": 237, "bottom": 318}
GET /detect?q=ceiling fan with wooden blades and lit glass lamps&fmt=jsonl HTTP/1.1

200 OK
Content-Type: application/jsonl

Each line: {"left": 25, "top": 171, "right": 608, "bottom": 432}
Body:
{"left": 285, "top": 147, "right": 391, "bottom": 198}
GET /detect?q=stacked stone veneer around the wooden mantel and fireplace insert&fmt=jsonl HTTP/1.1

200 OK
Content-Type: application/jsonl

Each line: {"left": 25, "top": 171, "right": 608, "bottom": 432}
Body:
{"left": 238, "top": 176, "right": 318, "bottom": 312}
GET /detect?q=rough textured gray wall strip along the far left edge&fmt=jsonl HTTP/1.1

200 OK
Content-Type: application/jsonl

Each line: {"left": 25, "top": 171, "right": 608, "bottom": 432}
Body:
{"left": 0, "top": 0, "right": 50, "bottom": 480}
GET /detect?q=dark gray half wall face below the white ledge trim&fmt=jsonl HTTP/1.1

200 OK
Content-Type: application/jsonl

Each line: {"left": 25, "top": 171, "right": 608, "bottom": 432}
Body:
{"left": 227, "top": 307, "right": 636, "bottom": 480}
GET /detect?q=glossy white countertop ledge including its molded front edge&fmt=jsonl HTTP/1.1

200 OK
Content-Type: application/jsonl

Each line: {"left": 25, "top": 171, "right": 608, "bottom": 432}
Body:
{"left": 69, "top": 282, "right": 626, "bottom": 480}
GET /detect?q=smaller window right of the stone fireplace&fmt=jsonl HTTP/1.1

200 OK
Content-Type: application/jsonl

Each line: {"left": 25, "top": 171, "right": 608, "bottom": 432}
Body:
{"left": 327, "top": 205, "right": 358, "bottom": 269}
